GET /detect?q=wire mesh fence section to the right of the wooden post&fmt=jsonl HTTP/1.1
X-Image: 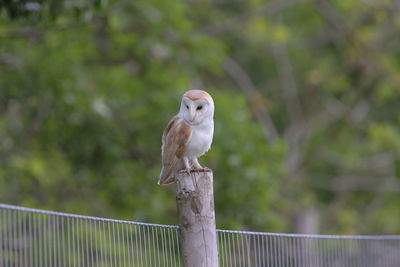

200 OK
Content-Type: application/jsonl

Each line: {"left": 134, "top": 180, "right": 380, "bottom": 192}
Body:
{"left": 218, "top": 230, "right": 400, "bottom": 267}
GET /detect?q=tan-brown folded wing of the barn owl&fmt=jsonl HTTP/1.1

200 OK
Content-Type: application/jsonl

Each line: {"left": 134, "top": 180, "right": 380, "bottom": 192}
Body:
{"left": 158, "top": 116, "right": 192, "bottom": 185}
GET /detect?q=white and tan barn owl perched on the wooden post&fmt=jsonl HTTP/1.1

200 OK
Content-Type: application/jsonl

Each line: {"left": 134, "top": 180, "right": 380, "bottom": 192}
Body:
{"left": 158, "top": 90, "right": 214, "bottom": 185}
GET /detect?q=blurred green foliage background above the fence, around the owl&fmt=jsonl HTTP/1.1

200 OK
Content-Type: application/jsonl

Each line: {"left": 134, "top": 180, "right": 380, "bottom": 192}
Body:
{"left": 0, "top": 0, "right": 400, "bottom": 234}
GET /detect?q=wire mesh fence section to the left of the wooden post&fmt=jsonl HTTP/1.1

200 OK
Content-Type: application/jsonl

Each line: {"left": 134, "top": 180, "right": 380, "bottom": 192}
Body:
{"left": 0, "top": 204, "right": 181, "bottom": 267}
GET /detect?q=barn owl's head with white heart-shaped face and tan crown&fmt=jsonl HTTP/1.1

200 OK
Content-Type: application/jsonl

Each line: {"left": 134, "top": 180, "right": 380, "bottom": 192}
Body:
{"left": 179, "top": 90, "right": 214, "bottom": 125}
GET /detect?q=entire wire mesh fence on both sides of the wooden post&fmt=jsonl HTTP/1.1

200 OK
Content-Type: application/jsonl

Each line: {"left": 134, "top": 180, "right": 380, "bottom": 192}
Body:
{"left": 0, "top": 204, "right": 400, "bottom": 267}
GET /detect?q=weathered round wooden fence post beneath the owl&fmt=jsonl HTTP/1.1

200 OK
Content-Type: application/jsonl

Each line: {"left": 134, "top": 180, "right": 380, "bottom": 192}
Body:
{"left": 175, "top": 170, "right": 219, "bottom": 267}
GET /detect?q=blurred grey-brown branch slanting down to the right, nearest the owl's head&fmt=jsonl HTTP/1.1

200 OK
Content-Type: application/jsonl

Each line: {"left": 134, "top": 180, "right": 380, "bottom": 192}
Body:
{"left": 224, "top": 58, "right": 279, "bottom": 143}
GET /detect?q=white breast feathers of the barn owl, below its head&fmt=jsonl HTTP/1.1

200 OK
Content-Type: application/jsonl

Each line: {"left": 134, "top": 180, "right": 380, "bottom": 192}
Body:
{"left": 186, "top": 119, "right": 214, "bottom": 158}
